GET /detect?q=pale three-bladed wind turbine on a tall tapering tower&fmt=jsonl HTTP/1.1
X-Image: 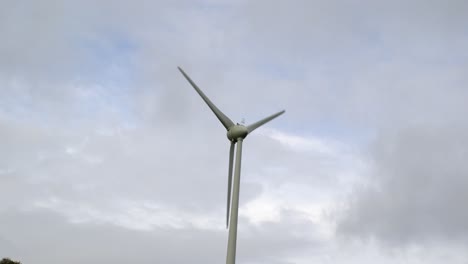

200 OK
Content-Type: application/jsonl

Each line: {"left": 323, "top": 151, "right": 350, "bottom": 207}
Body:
{"left": 177, "top": 67, "right": 285, "bottom": 264}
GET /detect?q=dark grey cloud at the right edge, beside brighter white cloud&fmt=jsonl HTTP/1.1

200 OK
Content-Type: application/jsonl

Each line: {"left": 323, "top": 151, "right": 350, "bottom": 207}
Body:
{"left": 339, "top": 124, "right": 468, "bottom": 245}
